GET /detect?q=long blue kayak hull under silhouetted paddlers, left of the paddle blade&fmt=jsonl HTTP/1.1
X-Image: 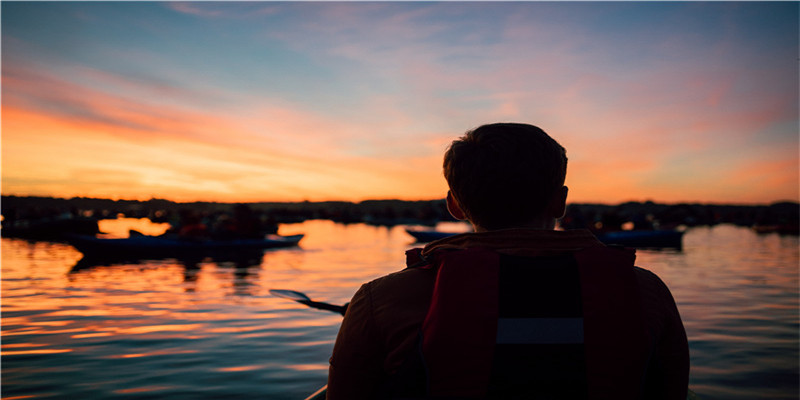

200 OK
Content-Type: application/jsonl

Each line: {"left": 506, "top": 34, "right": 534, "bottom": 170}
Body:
{"left": 67, "top": 235, "right": 303, "bottom": 257}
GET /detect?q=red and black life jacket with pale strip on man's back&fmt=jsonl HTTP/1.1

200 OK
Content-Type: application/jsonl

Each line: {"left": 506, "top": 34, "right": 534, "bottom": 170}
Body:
{"left": 388, "top": 246, "right": 652, "bottom": 399}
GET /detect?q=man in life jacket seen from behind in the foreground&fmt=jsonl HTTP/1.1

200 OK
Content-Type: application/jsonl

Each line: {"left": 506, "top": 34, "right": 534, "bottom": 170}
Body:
{"left": 327, "top": 123, "right": 689, "bottom": 400}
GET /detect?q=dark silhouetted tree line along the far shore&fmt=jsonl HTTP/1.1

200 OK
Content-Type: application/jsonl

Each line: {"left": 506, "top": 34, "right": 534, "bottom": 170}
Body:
{"left": 0, "top": 196, "right": 800, "bottom": 230}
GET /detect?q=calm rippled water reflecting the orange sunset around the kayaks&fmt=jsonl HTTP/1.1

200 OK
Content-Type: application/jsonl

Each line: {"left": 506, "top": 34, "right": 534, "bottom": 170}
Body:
{"left": 2, "top": 220, "right": 800, "bottom": 400}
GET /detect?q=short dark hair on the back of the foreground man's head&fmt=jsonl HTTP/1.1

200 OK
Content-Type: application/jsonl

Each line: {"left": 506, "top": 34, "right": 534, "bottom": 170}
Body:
{"left": 444, "top": 123, "right": 567, "bottom": 229}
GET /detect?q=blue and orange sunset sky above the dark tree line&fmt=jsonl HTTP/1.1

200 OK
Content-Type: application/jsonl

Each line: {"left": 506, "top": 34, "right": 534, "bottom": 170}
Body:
{"left": 1, "top": 2, "right": 800, "bottom": 203}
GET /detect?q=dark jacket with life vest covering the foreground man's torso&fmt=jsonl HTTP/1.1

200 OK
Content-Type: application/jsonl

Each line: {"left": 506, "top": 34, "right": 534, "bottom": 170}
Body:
{"left": 328, "top": 229, "right": 689, "bottom": 400}
